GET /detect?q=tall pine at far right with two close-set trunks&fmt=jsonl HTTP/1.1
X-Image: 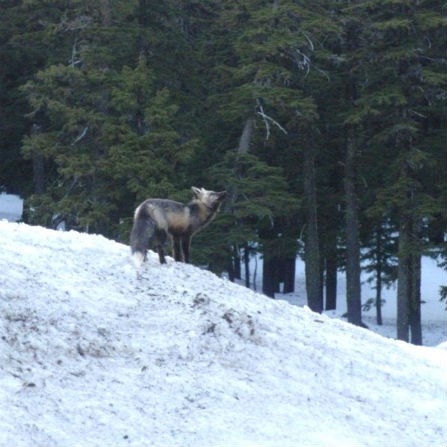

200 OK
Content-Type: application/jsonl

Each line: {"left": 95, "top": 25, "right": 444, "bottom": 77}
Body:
{"left": 346, "top": 1, "right": 445, "bottom": 344}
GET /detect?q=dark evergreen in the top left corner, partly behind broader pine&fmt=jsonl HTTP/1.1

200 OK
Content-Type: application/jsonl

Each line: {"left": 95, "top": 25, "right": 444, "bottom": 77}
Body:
{"left": 0, "top": 0, "right": 76, "bottom": 196}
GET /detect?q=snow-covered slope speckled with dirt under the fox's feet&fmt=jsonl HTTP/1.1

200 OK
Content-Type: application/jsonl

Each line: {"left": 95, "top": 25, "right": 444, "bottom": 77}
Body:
{"left": 0, "top": 222, "right": 447, "bottom": 447}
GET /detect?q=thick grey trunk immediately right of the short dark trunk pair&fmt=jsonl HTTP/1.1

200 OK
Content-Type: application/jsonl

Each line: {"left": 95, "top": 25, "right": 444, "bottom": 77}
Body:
{"left": 303, "top": 144, "right": 323, "bottom": 312}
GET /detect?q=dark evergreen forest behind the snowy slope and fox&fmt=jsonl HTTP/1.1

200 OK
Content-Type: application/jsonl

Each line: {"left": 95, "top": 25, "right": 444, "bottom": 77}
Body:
{"left": 0, "top": 0, "right": 447, "bottom": 344}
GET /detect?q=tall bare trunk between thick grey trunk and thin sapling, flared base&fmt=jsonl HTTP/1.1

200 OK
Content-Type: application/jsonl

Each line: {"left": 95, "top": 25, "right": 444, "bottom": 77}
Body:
{"left": 344, "top": 130, "right": 363, "bottom": 326}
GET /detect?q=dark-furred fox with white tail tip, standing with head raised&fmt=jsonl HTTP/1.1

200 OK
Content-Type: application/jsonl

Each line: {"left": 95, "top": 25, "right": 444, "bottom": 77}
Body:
{"left": 130, "top": 186, "right": 226, "bottom": 267}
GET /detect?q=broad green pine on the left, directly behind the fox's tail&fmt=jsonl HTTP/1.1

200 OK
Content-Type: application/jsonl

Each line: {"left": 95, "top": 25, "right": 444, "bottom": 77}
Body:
{"left": 18, "top": 2, "right": 196, "bottom": 237}
